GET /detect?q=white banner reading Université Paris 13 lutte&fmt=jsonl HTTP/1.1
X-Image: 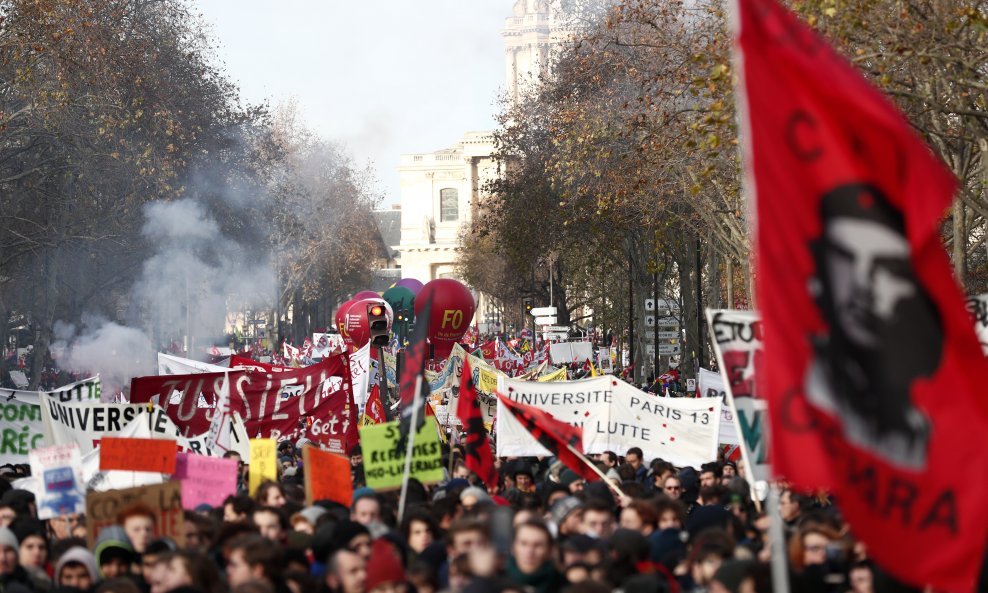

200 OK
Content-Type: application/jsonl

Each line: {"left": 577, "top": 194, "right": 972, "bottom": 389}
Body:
{"left": 497, "top": 376, "right": 720, "bottom": 467}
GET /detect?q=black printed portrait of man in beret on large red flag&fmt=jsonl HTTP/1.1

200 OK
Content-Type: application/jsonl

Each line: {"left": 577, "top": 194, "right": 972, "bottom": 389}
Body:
{"left": 805, "top": 184, "right": 944, "bottom": 469}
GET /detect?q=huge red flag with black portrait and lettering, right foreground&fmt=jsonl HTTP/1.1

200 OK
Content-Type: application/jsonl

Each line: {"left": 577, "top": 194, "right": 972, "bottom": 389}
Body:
{"left": 738, "top": 0, "right": 988, "bottom": 591}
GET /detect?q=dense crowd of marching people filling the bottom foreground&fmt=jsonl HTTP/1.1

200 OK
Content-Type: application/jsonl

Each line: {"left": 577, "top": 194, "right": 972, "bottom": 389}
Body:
{"left": 0, "top": 442, "right": 920, "bottom": 593}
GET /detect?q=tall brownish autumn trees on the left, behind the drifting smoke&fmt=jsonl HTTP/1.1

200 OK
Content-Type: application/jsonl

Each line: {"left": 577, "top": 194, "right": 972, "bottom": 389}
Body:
{"left": 0, "top": 0, "right": 376, "bottom": 383}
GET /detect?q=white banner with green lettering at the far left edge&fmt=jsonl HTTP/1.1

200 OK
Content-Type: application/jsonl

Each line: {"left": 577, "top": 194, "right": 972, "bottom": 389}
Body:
{"left": 0, "top": 377, "right": 100, "bottom": 465}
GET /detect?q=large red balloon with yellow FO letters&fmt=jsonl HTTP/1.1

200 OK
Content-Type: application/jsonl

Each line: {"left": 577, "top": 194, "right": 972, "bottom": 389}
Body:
{"left": 415, "top": 278, "right": 477, "bottom": 359}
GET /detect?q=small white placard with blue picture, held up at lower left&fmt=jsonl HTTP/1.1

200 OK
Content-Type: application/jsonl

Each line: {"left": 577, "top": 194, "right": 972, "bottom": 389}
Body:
{"left": 28, "top": 445, "right": 86, "bottom": 521}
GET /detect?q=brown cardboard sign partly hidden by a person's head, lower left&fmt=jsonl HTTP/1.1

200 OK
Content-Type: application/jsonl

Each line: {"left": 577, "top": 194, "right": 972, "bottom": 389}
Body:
{"left": 86, "top": 482, "right": 185, "bottom": 549}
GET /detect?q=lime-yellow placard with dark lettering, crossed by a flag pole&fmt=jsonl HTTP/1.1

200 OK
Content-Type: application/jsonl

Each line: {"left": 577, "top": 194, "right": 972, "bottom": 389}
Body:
{"left": 360, "top": 416, "right": 443, "bottom": 490}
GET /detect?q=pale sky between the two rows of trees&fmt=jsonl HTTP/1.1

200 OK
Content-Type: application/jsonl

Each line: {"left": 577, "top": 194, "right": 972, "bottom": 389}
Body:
{"left": 195, "top": 0, "right": 514, "bottom": 204}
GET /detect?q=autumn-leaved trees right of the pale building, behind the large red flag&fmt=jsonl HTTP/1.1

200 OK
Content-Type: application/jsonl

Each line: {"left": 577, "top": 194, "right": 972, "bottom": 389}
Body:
{"left": 463, "top": 0, "right": 988, "bottom": 377}
